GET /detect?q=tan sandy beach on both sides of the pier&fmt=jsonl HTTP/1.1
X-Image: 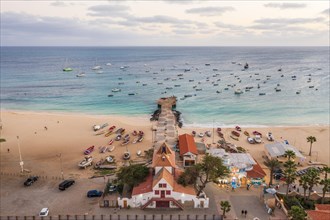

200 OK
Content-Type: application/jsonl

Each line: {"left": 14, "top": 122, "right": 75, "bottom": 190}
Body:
{"left": 1, "top": 110, "right": 330, "bottom": 178}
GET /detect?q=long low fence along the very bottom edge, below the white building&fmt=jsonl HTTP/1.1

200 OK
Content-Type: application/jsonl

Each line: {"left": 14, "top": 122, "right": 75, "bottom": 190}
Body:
{"left": 0, "top": 214, "right": 222, "bottom": 220}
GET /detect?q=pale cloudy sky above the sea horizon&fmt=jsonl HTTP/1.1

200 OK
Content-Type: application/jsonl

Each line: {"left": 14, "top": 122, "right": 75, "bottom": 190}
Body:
{"left": 0, "top": 0, "right": 329, "bottom": 46}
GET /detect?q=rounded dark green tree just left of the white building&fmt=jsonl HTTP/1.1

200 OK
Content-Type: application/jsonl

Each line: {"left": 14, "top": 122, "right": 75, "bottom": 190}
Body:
{"left": 117, "top": 164, "right": 149, "bottom": 189}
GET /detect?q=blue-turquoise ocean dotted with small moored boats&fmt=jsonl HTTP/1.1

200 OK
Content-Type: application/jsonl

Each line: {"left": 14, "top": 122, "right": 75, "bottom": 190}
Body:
{"left": 0, "top": 47, "right": 330, "bottom": 127}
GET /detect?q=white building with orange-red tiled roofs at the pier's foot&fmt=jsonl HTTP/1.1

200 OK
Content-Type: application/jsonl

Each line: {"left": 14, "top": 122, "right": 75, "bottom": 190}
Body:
{"left": 118, "top": 143, "right": 209, "bottom": 209}
